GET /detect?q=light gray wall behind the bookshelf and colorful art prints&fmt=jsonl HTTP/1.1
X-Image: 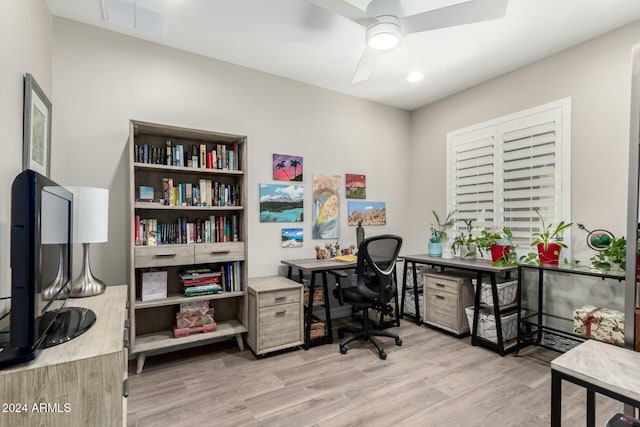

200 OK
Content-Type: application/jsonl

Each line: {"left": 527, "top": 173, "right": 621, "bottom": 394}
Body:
{"left": 52, "top": 18, "right": 410, "bottom": 283}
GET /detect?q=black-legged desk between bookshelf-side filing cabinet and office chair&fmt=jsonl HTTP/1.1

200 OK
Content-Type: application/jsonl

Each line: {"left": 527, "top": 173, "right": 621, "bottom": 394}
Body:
{"left": 281, "top": 258, "right": 356, "bottom": 350}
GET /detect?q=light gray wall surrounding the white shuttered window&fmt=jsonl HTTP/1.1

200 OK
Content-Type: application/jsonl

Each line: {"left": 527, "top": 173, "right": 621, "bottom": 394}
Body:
{"left": 405, "top": 22, "right": 640, "bottom": 314}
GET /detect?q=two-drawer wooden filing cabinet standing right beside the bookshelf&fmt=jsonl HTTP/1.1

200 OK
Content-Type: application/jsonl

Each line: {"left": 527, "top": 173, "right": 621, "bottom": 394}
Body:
{"left": 247, "top": 276, "right": 304, "bottom": 354}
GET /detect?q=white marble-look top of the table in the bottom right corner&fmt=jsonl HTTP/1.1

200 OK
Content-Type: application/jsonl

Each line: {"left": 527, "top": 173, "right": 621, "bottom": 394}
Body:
{"left": 551, "top": 340, "right": 640, "bottom": 401}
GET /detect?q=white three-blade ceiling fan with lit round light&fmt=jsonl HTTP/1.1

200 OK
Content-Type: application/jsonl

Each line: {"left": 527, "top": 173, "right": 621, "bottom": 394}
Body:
{"left": 309, "top": 0, "right": 509, "bottom": 84}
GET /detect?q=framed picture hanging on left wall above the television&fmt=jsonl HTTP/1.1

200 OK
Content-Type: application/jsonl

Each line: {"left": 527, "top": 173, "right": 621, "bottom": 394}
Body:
{"left": 22, "top": 73, "right": 51, "bottom": 177}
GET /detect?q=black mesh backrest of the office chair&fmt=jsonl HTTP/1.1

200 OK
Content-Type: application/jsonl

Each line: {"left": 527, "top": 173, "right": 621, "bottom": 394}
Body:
{"left": 356, "top": 234, "right": 402, "bottom": 304}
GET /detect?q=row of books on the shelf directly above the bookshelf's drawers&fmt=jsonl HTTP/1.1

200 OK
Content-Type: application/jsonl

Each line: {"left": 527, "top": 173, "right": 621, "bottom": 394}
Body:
{"left": 133, "top": 214, "right": 240, "bottom": 246}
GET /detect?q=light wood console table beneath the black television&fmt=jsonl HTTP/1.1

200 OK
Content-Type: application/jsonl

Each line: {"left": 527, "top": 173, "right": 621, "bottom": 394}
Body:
{"left": 0, "top": 286, "right": 128, "bottom": 427}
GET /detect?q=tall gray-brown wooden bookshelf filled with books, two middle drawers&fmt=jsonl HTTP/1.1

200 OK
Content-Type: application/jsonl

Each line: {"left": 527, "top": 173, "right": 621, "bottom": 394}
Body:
{"left": 128, "top": 120, "right": 248, "bottom": 373}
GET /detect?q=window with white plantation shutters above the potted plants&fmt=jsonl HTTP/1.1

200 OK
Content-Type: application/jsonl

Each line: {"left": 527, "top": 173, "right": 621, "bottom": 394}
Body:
{"left": 447, "top": 98, "right": 571, "bottom": 252}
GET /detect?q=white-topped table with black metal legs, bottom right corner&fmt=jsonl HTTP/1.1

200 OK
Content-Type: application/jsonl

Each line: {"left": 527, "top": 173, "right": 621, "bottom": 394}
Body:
{"left": 551, "top": 340, "right": 640, "bottom": 427}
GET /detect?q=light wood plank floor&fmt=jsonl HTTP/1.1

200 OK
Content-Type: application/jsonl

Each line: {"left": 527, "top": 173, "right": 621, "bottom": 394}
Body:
{"left": 127, "top": 320, "right": 623, "bottom": 427}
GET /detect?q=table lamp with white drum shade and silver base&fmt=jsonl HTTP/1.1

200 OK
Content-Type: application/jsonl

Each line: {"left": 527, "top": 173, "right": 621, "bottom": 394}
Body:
{"left": 65, "top": 187, "right": 109, "bottom": 297}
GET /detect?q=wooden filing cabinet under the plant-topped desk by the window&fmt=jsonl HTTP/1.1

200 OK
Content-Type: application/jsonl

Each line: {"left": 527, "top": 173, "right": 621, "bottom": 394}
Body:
{"left": 423, "top": 272, "right": 473, "bottom": 335}
